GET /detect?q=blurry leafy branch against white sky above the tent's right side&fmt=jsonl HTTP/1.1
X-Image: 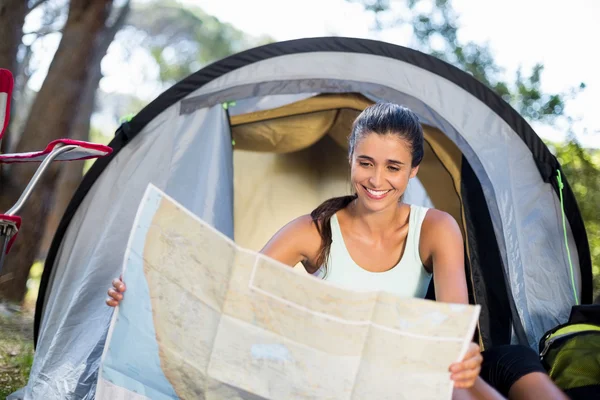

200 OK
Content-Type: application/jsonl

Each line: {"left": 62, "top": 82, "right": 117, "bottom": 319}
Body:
{"left": 347, "top": 0, "right": 585, "bottom": 123}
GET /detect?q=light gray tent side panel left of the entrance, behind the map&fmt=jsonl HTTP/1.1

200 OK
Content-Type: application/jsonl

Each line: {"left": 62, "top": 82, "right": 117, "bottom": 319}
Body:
{"left": 25, "top": 105, "right": 233, "bottom": 399}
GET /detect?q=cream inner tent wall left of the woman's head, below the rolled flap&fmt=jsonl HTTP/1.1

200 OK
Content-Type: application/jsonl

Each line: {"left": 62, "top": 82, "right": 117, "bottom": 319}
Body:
{"left": 233, "top": 136, "right": 351, "bottom": 251}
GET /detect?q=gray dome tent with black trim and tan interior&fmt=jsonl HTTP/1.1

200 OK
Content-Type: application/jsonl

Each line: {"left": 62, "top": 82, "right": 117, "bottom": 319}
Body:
{"left": 21, "top": 37, "right": 592, "bottom": 398}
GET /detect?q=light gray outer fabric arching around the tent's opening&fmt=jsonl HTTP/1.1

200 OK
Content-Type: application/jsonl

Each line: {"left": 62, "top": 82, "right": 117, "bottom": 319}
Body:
{"left": 25, "top": 39, "right": 581, "bottom": 399}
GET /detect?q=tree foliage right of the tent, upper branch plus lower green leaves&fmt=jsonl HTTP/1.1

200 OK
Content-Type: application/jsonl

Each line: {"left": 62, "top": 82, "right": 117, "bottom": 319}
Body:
{"left": 346, "top": 0, "right": 600, "bottom": 302}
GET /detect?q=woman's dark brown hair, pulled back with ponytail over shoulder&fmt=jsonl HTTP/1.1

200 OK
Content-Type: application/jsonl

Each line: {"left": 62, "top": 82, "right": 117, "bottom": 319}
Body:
{"left": 308, "top": 103, "right": 424, "bottom": 274}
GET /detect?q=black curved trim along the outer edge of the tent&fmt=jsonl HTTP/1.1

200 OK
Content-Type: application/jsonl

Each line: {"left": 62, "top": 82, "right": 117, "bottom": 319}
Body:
{"left": 34, "top": 37, "right": 592, "bottom": 345}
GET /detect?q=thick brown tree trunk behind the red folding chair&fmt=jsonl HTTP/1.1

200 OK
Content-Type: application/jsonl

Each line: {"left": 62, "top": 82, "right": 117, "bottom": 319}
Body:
{"left": 0, "top": 0, "right": 112, "bottom": 302}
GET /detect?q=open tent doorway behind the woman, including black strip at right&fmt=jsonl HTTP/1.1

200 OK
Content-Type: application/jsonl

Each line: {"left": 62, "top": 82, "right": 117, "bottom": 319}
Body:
{"left": 230, "top": 94, "right": 511, "bottom": 348}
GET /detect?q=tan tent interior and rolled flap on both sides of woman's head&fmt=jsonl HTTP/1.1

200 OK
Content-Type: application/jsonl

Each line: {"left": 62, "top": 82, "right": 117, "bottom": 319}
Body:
{"left": 230, "top": 93, "right": 467, "bottom": 250}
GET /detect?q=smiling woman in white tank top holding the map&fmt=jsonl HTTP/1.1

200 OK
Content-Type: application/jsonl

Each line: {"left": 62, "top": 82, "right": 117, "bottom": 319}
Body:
{"left": 107, "top": 103, "right": 568, "bottom": 398}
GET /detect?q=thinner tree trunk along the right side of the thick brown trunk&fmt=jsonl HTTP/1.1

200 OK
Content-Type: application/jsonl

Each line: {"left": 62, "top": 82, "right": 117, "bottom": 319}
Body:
{"left": 38, "top": 1, "right": 130, "bottom": 259}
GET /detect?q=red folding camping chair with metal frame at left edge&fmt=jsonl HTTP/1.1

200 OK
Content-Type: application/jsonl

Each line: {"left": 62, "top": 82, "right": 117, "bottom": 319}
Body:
{"left": 0, "top": 68, "right": 112, "bottom": 271}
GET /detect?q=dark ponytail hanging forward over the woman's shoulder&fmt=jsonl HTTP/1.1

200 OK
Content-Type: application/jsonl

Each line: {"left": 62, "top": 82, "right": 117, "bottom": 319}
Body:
{"left": 308, "top": 194, "right": 358, "bottom": 274}
